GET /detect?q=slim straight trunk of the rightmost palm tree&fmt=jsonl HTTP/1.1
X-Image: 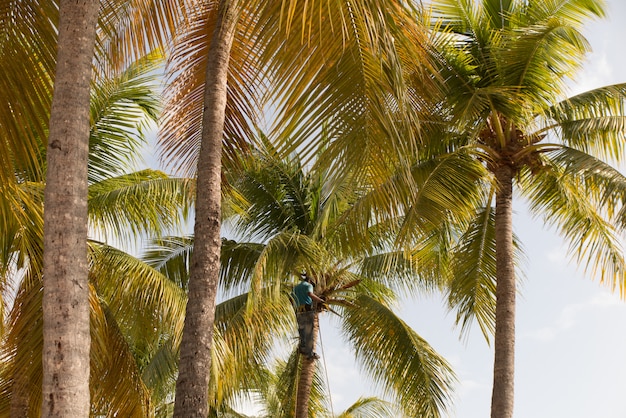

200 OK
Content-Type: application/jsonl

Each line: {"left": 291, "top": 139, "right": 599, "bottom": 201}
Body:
{"left": 491, "top": 165, "right": 516, "bottom": 418}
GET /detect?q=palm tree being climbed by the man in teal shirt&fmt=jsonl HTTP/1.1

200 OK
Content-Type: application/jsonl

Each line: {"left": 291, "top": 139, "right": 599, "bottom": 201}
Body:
{"left": 217, "top": 145, "right": 453, "bottom": 417}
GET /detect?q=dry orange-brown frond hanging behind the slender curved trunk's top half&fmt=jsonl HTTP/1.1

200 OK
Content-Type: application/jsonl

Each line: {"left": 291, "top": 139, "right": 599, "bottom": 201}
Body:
{"left": 159, "top": 1, "right": 262, "bottom": 177}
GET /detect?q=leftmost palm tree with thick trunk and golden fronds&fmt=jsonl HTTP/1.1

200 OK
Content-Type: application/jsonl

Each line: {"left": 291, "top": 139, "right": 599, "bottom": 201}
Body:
{"left": 0, "top": 0, "right": 191, "bottom": 416}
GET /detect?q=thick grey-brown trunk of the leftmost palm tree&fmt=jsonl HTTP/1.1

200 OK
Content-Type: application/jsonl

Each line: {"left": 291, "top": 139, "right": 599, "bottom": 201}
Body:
{"left": 42, "top": 0, "right": 100, "bottom": 418}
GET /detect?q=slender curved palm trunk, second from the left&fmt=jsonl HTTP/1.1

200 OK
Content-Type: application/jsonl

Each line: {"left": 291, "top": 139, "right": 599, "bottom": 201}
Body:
{"left": 174, "top": 0, "right": 239, "bottom": 418}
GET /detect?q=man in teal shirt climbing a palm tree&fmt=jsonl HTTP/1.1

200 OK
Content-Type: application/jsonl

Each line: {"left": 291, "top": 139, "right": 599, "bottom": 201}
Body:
{"left": 292, "top": 273, "right": 324, "bottom": 360}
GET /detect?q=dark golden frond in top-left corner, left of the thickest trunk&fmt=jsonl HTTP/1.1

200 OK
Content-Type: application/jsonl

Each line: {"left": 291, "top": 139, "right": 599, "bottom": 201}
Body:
{"left": 0, "top": 1, "right": 58, "bottom": 184}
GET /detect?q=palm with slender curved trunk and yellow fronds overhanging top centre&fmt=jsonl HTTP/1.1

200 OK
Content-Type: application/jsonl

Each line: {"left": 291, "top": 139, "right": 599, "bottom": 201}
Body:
{"left": 158, "top": 0, "right": 436, "bottom": 417}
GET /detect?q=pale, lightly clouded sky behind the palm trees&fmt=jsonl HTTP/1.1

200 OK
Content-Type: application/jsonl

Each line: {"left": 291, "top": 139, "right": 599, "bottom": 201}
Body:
{"left": 318, "top": 0, "right": 626, "bottom": 418}
